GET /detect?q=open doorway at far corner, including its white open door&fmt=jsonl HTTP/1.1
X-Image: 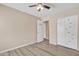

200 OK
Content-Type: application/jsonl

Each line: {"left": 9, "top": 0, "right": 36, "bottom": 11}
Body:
{"left": 37, "top": 20, "right": 49, "bottom": 42}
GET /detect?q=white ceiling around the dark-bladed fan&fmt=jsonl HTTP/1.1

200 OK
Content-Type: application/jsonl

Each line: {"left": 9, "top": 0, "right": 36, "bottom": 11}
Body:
{"left": 3, "top": 3, "right": 79, "bottom": 17}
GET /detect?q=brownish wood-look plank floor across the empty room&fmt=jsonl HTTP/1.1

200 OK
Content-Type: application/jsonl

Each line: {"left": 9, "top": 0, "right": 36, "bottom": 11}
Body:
{"left": 0, "top": 40, "right": 79, "bottom": 56}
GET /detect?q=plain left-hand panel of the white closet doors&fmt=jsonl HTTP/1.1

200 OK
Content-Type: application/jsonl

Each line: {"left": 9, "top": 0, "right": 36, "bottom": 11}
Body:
{"left": 57, "top": 19, "right": 65, "bottom": 46}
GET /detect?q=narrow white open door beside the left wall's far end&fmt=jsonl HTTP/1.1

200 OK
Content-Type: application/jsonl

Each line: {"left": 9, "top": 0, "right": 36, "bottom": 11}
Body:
{"left": 37, "top": 20, "right": 44, "bottom": 42}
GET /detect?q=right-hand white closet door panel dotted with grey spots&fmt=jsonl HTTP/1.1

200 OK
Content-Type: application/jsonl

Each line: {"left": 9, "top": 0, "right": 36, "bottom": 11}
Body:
{"left": 64, "top": 16, "right": 77, "bottom": 49}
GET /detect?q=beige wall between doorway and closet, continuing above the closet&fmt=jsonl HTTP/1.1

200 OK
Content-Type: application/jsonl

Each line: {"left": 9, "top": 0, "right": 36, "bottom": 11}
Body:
{"left": 49, "top": 8, "right": 79, "bottom": 44}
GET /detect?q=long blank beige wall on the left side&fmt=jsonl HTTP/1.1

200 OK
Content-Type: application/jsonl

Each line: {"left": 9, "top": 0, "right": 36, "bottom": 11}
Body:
{"left": 0, "top": 5, "right": 38, "bottom": 51}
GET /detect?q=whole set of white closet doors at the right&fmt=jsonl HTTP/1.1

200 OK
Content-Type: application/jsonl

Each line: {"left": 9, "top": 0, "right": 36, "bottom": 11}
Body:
{"left": 57, "top": 16, "right": 77, "bottom": 49}
